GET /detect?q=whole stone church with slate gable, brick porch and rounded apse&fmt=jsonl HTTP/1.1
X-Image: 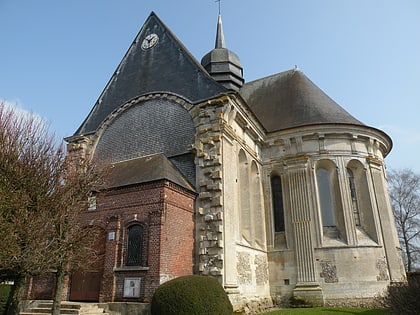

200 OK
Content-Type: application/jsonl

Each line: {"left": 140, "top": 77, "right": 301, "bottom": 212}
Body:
{"left": 30, "top": 12, "right": 405, "bottom": 309}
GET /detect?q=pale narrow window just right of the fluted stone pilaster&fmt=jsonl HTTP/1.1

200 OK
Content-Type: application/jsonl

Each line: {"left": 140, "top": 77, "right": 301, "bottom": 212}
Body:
{"left": 316, "top": 167, "right": 336, "bottom": 226}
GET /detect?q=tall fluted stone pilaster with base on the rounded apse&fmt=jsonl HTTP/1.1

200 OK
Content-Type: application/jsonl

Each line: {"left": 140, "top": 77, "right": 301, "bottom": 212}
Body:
{"left": 285, "top": 155, "right": 324, "bottom": 305}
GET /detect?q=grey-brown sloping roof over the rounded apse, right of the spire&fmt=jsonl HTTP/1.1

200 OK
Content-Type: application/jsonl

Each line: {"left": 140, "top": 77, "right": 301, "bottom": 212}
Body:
{"left": 239, "top": 69, "right": 364, "bottom": 132}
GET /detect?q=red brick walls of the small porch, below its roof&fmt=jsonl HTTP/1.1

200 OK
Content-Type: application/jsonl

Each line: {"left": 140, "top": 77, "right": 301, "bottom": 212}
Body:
{"left": 83, "top": 180, "right": 195, "bottom": 302}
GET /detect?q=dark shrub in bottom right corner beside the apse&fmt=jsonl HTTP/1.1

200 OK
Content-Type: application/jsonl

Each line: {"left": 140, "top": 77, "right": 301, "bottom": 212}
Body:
{"left": 382, "top": 278, "right": 420, "bottom": 315}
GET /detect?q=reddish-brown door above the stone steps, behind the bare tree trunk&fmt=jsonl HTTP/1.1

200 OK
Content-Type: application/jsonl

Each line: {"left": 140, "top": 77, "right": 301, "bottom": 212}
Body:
{"left": 70, "top": 271, "right": 102, "bottom": 302}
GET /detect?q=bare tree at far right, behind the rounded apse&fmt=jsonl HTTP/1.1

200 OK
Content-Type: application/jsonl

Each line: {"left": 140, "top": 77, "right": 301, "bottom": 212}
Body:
{"left": 388, "top": 169, "right": 420, "bottom": 272}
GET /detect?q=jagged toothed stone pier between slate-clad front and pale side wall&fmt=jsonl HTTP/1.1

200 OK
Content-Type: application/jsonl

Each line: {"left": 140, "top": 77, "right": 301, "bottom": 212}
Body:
{"left": 192, "top": 100, "right": 223, "bottom": 281}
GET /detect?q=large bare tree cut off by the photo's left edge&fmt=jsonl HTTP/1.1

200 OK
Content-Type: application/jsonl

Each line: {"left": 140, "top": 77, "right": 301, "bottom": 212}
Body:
{"left": 0, "top": 104, "right": 64, "bottom": 314}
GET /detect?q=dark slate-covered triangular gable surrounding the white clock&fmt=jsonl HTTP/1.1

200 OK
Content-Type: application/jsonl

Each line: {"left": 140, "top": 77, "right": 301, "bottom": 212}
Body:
{"left": 75, "top": 12, "right": 228, "bottom": 135}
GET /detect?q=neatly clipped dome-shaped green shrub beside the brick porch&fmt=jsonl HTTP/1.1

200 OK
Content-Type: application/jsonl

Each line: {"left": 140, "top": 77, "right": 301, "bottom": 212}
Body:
{"left": 151, "top": 276, "right": 233, "bottom": 315}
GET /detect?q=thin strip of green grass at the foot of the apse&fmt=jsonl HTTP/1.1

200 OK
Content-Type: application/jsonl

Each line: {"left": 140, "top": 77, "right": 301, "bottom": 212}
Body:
{"left": 262, "top": 307, "right": 389, "bottom": 315}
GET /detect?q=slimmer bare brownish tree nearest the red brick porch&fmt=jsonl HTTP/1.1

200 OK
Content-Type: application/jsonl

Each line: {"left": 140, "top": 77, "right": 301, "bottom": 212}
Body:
{"left": 49, "top": 159, "right": 105, "bottom": 315}
